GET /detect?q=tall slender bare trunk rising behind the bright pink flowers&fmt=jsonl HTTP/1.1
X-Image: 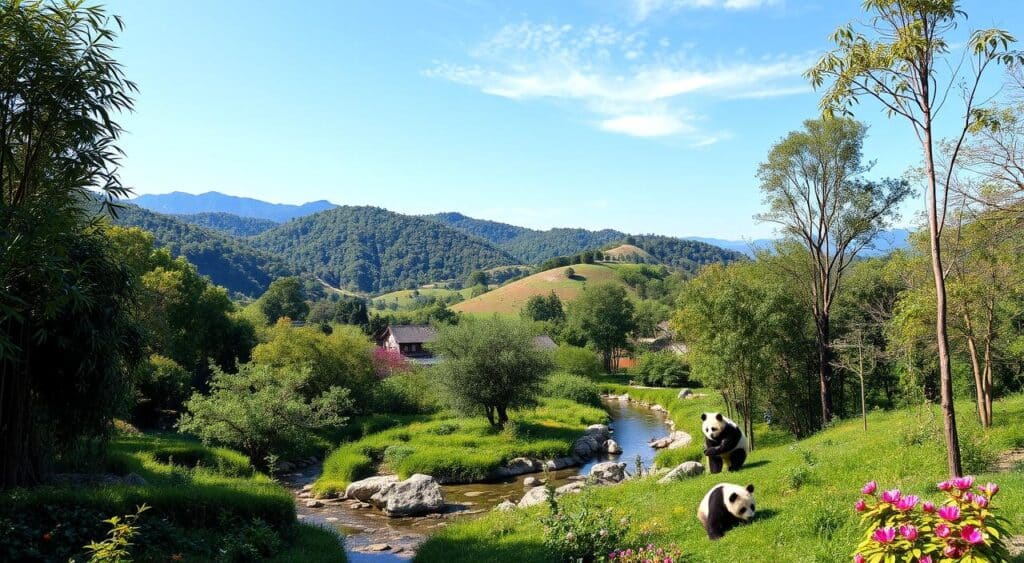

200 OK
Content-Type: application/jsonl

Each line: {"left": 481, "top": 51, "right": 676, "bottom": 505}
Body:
{"left": 924, "top": 130, "right": 964, "bottom": 477}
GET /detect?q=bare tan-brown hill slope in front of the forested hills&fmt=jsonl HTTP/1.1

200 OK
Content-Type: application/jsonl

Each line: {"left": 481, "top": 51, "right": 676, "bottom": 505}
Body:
{"left": 452, "top": 264, "right": 632, "bottom": 314}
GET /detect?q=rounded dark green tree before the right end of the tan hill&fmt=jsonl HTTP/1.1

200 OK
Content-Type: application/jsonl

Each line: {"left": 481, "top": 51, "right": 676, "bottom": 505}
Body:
{"left": 567, "top": 284, "right": 636, "bottom": 372}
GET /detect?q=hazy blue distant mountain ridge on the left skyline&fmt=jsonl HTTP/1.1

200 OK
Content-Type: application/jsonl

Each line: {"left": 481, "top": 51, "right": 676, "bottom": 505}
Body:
{"left": 129, "top": 191, "right": 337, "bottom": 223}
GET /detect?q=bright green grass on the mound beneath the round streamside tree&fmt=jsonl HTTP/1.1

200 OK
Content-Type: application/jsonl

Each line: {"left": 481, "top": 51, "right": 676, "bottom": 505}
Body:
{"left": 313, "top": 398, "right": 607, "bottom": 495}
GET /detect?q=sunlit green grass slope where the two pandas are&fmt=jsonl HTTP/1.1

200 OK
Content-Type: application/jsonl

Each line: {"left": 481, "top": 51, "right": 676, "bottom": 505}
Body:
{"left": 416, "top": 389, "right": 1024, "bottom": 563}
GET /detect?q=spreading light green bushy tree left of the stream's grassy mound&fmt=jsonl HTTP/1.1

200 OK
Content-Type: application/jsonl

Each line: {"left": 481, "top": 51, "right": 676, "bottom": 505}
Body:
{"left": 178, "top": 363, "right": 351, "bottom": 468}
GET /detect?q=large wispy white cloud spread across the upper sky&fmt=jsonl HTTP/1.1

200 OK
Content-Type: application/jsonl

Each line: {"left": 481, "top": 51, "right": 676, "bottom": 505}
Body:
{"left": 425, "top": 22, "right": 811, "bottom": 145}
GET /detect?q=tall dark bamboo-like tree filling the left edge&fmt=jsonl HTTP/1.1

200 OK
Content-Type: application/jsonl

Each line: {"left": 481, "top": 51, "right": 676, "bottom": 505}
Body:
{"left": 0, "top": 1, "right": 138, "bottom": 489}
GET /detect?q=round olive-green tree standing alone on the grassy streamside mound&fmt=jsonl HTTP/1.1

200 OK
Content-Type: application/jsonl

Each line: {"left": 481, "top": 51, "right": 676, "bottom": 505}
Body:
{"left": 430, "top": 316, "right": 553, "bottom": 427}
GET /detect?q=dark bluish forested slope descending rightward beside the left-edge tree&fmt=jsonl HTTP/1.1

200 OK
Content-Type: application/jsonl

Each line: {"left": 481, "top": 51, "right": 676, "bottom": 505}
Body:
{"left": 114, "top": 205, "right": 292, "bottom": 297}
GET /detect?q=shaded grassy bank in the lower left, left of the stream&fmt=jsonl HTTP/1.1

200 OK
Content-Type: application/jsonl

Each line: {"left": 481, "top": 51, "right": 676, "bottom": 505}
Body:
{"left": 0, "top": 435, "right": 344, "bottom": 561}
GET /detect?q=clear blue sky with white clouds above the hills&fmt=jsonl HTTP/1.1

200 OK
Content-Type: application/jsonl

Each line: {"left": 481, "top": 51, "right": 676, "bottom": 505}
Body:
{"left": 109, "top": 0, "right": 1024, "bottom": 239}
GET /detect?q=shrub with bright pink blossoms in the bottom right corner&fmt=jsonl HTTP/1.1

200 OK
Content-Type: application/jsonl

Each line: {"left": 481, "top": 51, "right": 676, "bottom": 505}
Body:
{"left": 853, "top": 477, "right": 1009, "bottom": 563}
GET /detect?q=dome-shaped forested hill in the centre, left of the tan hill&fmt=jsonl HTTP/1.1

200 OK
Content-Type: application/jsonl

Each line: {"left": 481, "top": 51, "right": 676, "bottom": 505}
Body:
{"left": 253, "top": 207, "right": 517, "bottom": 293}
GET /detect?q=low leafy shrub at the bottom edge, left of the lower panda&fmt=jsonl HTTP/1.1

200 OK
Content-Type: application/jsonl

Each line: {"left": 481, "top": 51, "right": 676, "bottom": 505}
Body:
{"left": 542, "top": 489, "right": 629, "bottom": 563}
